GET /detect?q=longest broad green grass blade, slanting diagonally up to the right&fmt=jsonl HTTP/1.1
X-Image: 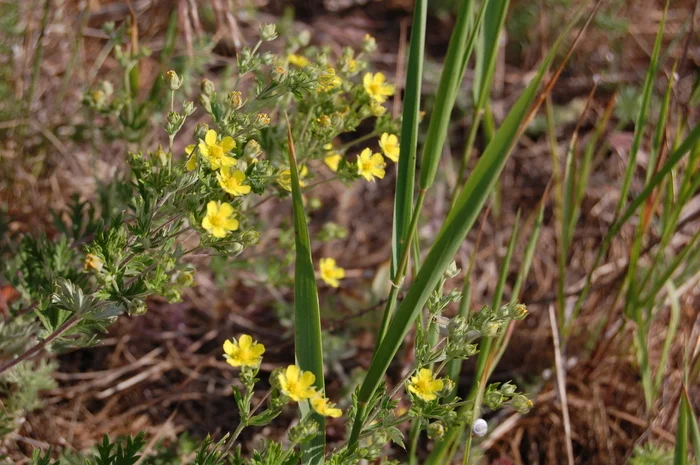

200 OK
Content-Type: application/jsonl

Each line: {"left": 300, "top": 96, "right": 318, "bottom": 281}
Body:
{"left": 349, "top": 23, "right": 559, "bottom": 450}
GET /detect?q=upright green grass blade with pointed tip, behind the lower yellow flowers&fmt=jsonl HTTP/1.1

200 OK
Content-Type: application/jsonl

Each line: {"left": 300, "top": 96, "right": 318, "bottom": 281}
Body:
{"left": 287, "top": 120, "right": 325, "bottom": 465}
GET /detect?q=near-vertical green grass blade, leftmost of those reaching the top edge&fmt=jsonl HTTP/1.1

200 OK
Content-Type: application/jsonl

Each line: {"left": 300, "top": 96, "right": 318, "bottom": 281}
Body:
{"left": 391, "top": 0, "right": 428, "bottom": 275}
